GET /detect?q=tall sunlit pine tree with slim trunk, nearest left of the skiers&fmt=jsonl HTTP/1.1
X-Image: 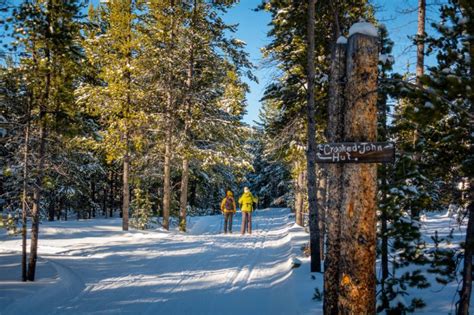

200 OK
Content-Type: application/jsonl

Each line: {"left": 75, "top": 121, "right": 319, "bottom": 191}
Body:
{"left": 174, "top": 0, "right": 253, "bottom": 231}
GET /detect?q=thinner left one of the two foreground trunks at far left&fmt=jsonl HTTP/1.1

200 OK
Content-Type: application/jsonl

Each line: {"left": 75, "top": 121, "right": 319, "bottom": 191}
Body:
{"left": 21, "top": 103, "right": 31, "bottom": 281}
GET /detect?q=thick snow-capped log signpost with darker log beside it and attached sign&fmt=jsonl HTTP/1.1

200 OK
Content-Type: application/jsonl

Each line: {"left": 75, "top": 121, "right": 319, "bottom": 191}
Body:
{"left": 322, "top": 21, "right": 395, "bottom": 314}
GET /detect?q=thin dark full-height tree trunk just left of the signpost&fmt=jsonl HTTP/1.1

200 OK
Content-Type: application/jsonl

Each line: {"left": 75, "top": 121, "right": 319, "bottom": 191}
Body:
{"left": 306, "top": 0, "right": 321, "bottom": 272}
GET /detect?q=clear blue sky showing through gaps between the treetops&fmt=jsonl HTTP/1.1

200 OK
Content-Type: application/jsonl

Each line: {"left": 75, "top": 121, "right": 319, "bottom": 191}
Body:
{"left": 224, "top": 0, "right": 439, "bottom": 125}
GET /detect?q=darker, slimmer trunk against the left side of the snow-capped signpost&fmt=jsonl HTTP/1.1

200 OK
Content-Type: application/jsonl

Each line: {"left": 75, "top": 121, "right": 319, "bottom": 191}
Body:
{"left": 323, "top": 39, "right": 347, "bottom": 315}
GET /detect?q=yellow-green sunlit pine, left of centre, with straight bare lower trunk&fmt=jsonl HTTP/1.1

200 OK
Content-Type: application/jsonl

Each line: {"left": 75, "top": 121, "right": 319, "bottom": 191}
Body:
{"left": 77, "top": 0, "right": 145, "bottom": 230}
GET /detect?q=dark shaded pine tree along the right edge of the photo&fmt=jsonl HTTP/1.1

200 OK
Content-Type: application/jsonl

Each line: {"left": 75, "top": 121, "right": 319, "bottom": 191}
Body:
{"left": 416, "top": 0, "right": 474, "bottom": 314}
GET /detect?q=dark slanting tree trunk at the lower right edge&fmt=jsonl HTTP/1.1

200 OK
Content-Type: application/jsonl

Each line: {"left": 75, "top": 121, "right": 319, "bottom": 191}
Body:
{"left": 457, "top": 186, "right": 474, "bottom": 315}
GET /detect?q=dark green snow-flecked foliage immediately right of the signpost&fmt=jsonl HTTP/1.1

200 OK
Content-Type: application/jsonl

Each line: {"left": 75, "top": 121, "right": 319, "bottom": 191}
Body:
{"left": 377, "top": 25, "right": 432, "bottom": 314}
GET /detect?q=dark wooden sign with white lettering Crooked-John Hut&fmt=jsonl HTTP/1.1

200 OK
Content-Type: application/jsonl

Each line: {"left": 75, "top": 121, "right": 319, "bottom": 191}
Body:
{"left": 316, "top": 142, "right": 395, "bottom": 163}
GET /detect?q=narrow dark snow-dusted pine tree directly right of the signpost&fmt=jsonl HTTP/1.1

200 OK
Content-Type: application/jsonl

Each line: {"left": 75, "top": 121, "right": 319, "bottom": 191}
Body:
{"left": 378, "top": 22, "right": 429, "bottom": 311}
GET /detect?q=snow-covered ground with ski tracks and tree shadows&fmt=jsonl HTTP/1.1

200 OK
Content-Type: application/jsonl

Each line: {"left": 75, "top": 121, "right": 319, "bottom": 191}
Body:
{"left": 0, "top": 209, "right": 470, "bottom": 315}
